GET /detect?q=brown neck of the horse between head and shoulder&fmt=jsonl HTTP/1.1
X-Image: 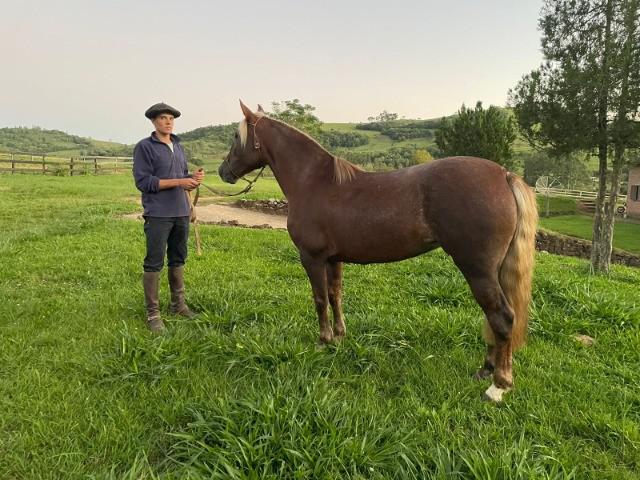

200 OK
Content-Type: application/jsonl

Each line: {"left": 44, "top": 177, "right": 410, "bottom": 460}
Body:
{"left": 267, "top": 125, "right": 333, "bottom": 201}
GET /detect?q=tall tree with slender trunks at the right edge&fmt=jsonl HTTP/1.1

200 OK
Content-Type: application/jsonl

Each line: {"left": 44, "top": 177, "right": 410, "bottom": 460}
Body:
{"left": 510, "top": 0, "right": 640, "bottom": 272}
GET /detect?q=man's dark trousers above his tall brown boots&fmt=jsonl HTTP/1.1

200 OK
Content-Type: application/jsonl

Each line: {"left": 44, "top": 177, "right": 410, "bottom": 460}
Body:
{"left": 143, "top": 217, "right": 189, "bottom": 272}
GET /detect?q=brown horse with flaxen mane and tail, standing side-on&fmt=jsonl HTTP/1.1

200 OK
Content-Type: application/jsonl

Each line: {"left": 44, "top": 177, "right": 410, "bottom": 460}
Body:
{"left": 218, "top": 101, "right": 538, "bottom": 402}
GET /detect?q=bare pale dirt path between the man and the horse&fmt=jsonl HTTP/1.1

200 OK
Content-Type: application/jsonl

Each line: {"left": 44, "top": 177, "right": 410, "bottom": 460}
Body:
{"left": 127, "top": 203, "right": 287, "bottom": 230}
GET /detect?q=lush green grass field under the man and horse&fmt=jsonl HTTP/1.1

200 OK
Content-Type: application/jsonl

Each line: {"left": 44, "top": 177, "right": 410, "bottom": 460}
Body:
{"left": 0, "top": 175, "right": 640, "bottom": 479}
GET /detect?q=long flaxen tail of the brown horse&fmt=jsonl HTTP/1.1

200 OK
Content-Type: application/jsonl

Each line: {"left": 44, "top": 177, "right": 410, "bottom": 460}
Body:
{"left": 500, "top": 173, "right": 538, "bottom": 350}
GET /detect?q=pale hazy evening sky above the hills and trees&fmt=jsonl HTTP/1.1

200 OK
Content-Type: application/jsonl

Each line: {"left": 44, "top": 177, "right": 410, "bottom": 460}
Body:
{"left": 0, "top": 0, "right": 542, "bottom": 143}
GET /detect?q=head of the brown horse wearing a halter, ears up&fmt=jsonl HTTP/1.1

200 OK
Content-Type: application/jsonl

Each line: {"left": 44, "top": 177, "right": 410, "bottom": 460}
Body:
{"left": 218, "top": 100, "right": 266, "bottom": 183}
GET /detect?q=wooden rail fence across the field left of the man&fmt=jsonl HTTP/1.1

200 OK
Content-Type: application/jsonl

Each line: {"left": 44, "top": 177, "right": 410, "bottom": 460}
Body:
{"left": 0, "top": 153, "right": 133, "bottom": 176}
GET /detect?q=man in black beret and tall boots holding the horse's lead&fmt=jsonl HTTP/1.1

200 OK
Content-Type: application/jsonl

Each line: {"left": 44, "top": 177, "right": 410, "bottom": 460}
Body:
{"left": 133, "top": 103, "right": 204, "bottom": 333}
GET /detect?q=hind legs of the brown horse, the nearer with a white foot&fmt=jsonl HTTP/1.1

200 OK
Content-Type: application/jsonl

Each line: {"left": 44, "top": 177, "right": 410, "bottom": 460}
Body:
{"left": 467, "top": 275, "right": 514, "bottom": 402}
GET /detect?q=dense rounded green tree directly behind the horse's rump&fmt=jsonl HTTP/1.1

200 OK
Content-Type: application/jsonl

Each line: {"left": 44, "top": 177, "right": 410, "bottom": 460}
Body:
{"left": 436, "top": 102, "right": 516, "bottom": 168}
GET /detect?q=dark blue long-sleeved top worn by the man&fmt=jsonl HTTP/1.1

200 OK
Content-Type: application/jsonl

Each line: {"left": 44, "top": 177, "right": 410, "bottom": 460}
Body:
{"left": 133, "top": 132, "right": 191, "bottom": 217}
